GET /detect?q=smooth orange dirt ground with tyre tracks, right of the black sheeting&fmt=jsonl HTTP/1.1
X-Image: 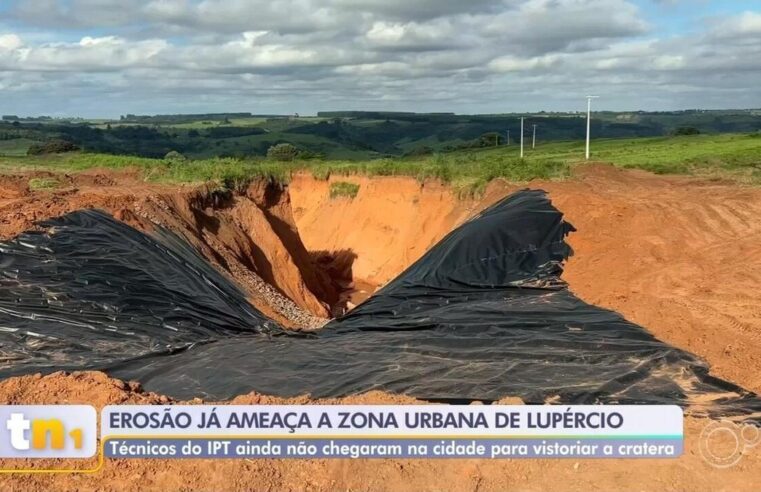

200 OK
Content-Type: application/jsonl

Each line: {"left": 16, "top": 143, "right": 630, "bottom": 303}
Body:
{"left": 547, "top": 166, "right": 761, "bottom": 392}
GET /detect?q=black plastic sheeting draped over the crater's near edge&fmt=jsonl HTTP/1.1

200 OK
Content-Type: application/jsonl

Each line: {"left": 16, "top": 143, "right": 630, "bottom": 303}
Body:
{"left": 0, "top": 190, "right": 761, "bottom": 415}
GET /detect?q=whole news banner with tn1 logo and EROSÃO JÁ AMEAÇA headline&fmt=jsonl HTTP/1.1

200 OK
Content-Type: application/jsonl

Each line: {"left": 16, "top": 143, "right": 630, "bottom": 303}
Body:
{"left": 0, "top": 405, "right": 684, "bottom": 459}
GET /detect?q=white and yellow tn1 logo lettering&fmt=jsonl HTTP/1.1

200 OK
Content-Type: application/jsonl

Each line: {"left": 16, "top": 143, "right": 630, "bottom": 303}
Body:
{"left": 6, "top": 413, "right": 82, "bottom": 451}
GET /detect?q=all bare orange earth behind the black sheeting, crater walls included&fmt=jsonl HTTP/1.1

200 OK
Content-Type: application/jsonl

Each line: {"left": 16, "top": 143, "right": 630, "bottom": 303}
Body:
{"left": 0, "top": 165, "right": 761, "bottom": 392}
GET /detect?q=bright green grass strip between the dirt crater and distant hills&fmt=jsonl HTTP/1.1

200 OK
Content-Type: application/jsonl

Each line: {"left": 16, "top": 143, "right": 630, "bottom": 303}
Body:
{"left": 0, "top": 134, "right": 761, "bottom": 194}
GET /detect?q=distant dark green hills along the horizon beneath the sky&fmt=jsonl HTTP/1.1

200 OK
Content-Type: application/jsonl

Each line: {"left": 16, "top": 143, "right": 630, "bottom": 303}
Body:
{"left": 0, "top": 110, "right": 761, "bottom": 160}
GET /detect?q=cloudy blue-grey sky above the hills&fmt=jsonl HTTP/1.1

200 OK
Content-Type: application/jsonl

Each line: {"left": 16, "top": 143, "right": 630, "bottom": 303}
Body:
{"left": 0, "top": 0, "right": 761, "bottom": 118}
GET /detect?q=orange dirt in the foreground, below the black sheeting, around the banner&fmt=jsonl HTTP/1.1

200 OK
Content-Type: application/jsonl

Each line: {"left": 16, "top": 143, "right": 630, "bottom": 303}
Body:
{"left": 0, "top": 372, "right": 761, "bottom": 491}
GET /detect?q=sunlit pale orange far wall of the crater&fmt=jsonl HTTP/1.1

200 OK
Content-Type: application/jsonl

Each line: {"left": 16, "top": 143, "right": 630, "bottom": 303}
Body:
{"left": 289, "top": 174, "right": 481, "bottom": 286}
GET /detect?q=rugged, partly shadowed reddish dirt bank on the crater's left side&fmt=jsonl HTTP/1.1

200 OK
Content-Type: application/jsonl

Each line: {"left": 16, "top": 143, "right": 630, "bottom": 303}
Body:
{"left": 0, "top": 173, "right": 338, "bottom": 328}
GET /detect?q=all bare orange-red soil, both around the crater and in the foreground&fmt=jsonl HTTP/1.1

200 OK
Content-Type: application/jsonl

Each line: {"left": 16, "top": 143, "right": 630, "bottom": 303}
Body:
{"left": 0, "top": 166, "right": 761, "bottom": 490}
